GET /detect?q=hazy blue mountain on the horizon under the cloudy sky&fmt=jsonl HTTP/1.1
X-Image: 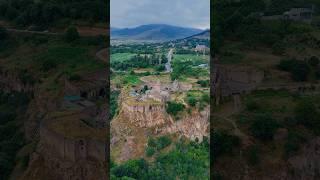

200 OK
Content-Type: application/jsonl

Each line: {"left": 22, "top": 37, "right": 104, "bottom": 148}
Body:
{"left": 111, "top": 24, "right": 203, "bottom": 40}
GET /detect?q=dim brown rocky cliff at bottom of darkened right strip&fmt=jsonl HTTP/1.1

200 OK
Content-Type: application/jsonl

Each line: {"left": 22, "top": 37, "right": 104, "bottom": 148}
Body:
{"left": 216, "top": 137, "right": 320, "bottom": 180}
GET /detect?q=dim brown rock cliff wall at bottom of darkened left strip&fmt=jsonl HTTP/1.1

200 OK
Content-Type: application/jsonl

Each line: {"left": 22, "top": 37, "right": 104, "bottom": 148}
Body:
{"left": 22, "top": 111, "right": 107, "bottom": 180}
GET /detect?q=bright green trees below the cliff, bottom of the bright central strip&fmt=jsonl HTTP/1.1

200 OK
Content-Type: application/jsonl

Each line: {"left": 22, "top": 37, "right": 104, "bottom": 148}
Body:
{"left": 111, "top": 138, "right": 209, "bottom": 180}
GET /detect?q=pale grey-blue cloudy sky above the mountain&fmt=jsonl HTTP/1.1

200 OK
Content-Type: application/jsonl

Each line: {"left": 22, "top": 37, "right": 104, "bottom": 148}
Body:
{"left": 110, "top": 0, "right": 210, "bottom": 29}
